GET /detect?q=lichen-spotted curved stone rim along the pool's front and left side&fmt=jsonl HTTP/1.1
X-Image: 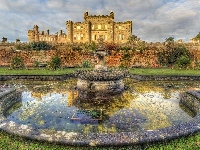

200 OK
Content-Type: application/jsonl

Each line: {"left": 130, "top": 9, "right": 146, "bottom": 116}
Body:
{"left": 0, "top": 89, "right": 200, "bottom": 146}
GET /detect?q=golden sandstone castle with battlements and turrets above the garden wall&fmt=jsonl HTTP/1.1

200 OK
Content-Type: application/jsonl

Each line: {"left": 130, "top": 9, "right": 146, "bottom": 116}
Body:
{"left": 28, "top": 11, "right": 132, "bottom": 43}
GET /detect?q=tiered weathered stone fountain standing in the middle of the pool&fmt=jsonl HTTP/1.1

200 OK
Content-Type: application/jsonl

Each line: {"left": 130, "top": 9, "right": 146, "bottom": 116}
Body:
{"left": 77, "top": 38, "right": 125, "bottom": 98}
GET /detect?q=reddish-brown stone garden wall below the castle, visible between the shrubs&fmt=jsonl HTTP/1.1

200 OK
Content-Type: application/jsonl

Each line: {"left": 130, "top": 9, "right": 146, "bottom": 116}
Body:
{"left": 0, "top": 42, "right": 200, "bottom": 67}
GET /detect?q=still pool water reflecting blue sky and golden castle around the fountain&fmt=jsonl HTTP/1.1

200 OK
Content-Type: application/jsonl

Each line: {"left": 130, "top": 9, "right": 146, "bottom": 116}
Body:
{"left": 0, "top": 79, "right": 200, "bottom": 134}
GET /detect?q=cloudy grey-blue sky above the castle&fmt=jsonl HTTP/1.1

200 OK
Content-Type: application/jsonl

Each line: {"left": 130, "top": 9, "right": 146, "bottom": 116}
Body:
{"left": 0, "top": 0, "right": 200, "bottom": 42}
